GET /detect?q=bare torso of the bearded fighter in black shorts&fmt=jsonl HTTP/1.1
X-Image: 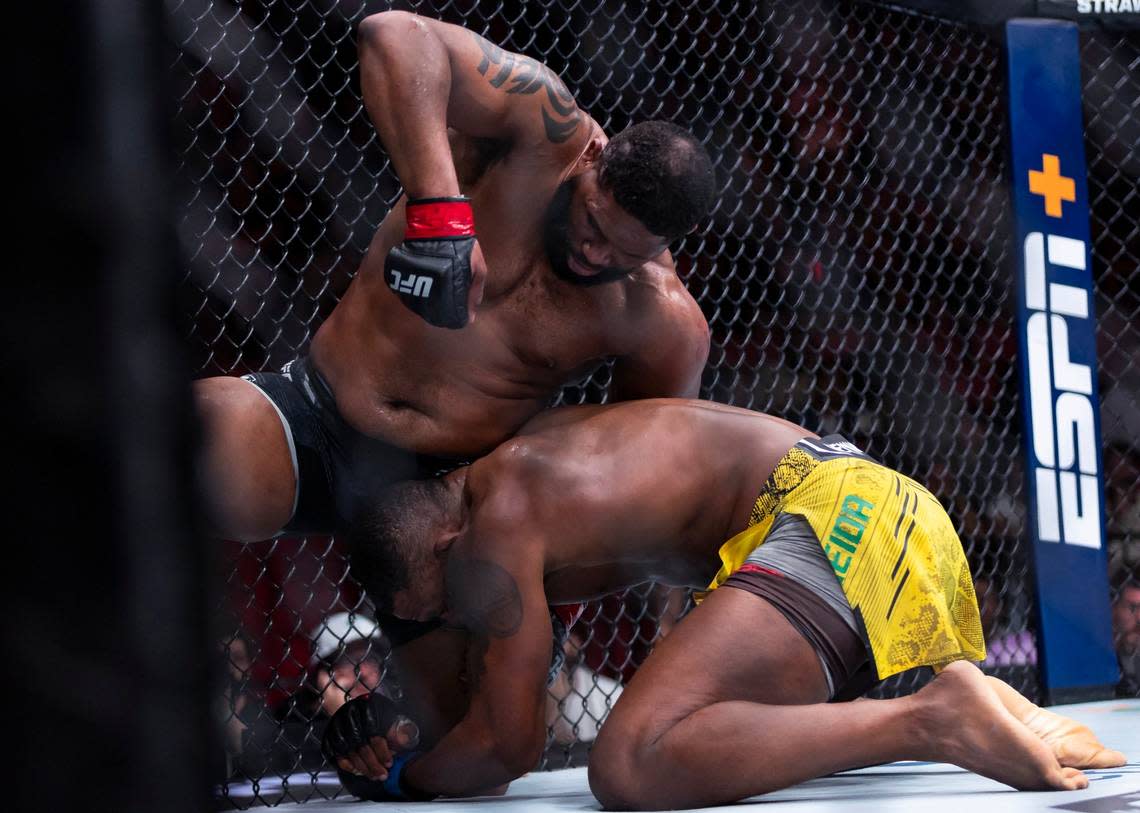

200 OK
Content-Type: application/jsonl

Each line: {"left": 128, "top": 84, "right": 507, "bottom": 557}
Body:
{"left": 311, "top": 122, "right": 671, "bottom": 456}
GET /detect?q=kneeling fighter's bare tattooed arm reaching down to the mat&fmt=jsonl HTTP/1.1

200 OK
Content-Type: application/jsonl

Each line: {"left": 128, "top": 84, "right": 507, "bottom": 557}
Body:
{"left": 405, "top": 538, "right": 552, "bottom": 796}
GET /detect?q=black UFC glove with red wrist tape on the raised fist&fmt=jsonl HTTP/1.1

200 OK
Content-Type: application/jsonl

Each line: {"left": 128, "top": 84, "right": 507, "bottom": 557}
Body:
{"left": 384, "top": 197, "right": 475, "bottom": 330}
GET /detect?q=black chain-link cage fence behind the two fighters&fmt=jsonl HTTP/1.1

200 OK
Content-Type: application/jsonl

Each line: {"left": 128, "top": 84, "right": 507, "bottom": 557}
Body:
{"left": 168, "top": 0, "right": 1140, "bottom": 806}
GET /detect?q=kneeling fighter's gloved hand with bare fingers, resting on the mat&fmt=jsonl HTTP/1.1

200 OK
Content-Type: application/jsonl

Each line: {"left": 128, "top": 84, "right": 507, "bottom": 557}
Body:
{"left": 320, "top": 693, "right": 420, "bottom": 782}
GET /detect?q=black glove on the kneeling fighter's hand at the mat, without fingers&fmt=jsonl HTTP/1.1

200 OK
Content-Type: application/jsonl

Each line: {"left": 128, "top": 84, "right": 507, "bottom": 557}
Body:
{"left": 320, "top": 693, "right": 435, "bottom": 802}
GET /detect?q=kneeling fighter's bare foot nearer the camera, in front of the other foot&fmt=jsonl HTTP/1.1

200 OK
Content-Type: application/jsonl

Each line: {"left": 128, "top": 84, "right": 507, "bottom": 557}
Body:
{"left": 914, "top": 660, "right": 1089, "bottom": 790}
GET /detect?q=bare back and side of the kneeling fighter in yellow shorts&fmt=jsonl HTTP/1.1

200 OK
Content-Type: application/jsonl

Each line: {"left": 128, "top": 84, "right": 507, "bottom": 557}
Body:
{"left": 458, "top": 399, "right": 813, "bottom": 603}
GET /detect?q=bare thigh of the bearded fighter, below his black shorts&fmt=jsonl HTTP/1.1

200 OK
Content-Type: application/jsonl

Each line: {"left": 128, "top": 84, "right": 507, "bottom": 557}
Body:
{"left": 194, "top": 376, "right": 296, "bottom": 542}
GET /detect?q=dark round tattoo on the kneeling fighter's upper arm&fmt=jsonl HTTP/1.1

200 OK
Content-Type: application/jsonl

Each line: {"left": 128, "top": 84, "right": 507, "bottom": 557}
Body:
{"left": 447, "top": 559, "right": 522, "bottom": 639}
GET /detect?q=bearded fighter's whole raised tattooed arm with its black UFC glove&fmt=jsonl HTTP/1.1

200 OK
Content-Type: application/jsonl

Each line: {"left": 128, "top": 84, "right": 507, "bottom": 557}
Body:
{"left": 357, "top": 11, "right": 592, "bottom": 330}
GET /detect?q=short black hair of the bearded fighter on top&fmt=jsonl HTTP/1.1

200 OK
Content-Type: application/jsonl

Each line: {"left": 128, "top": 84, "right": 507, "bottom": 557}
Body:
{"left": 599, "top": 121, "right": 716, "bottom": 243}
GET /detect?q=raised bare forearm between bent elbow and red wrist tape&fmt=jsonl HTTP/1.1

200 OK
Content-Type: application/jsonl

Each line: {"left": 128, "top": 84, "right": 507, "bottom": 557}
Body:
{"left": 358, "top": 13, "right": 459, "bottom": 198}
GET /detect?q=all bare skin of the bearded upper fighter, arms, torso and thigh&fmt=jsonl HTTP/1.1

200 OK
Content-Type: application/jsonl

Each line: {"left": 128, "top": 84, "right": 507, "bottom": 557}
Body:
{"left": 196, "top": 11, "right": 709, "bottom": 539}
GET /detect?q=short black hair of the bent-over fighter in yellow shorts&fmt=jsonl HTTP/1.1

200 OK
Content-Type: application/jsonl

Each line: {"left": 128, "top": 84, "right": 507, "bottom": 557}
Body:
{"left": 348, "top": 480, "right": 446, "bottom": 613}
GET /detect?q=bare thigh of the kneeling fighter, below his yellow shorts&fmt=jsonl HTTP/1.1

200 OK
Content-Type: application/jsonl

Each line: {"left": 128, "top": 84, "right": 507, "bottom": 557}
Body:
{"left": 606, "top": 587, "right": 828, "bottom": 738}
